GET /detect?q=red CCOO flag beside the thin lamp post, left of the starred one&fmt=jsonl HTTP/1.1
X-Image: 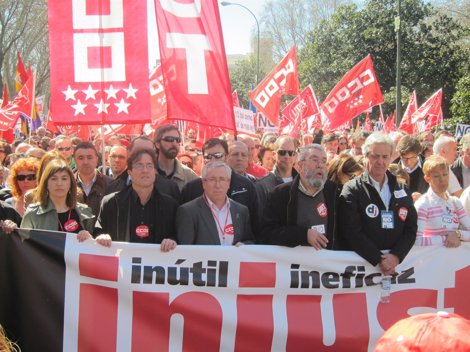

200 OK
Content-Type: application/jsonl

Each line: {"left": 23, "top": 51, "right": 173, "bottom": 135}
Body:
{"left": 250, "top": 46, "right": 300, "bottom": 126}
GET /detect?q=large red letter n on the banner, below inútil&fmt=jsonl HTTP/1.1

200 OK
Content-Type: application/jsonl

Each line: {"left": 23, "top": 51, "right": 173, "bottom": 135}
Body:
{"left": 132, "top": 292, "right": 223, "bottom": 352}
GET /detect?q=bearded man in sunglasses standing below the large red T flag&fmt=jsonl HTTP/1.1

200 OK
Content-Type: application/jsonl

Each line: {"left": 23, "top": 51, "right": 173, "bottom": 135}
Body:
{"left": 154, "top": 124, "right": 198, "bottom": 191}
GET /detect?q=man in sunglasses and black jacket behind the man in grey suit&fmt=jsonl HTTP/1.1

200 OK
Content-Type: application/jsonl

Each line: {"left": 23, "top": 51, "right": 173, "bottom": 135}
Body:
{"left": 181, "top": 138, "right": 258, "bottom": 234}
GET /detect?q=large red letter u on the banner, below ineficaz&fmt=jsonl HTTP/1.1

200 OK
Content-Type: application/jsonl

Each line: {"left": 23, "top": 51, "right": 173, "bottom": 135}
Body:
{"left": 286, "top": 294, "right": 369, "bottom": 352}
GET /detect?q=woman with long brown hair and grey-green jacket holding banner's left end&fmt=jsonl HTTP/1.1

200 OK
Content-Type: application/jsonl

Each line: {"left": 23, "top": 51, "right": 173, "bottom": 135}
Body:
{"left": 21, "top": 158, "right": 95, "bottom": 242}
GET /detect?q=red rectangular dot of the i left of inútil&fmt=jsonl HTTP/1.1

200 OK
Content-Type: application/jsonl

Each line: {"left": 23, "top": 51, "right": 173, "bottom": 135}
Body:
{"left": 78, "top": 254, "right": 119, "bottom": 281}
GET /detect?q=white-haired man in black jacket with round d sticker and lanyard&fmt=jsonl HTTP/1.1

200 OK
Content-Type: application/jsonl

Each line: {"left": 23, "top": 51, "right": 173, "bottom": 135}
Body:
{"left": 338, "top": 132, "right": 417, "bottom": 275}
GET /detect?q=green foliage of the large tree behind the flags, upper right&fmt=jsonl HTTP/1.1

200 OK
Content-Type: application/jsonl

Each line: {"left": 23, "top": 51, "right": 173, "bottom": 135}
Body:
{"left": 299, "top": 0, "right": 469, "bottom": 117}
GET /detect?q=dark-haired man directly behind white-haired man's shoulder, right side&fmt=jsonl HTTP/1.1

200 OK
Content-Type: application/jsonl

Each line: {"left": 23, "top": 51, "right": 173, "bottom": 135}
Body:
{"left": 397, "top": 135, "right": 429, "bottom": 200}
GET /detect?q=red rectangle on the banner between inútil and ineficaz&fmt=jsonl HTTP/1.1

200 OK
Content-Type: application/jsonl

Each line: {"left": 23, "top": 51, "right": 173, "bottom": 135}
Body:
{"left": 239, "top": 262, "right": 276, "bottom": 287}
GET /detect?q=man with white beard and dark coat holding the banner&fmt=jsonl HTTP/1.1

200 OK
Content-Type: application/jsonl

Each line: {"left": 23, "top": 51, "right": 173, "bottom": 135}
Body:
{"left": 261, "top": 144, "right": 338, "bottom": 250}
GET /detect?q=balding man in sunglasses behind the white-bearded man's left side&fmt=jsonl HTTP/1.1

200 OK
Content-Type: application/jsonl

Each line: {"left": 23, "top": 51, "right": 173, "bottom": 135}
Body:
{"left": 256, "top": 136, "right": 297, "bottom": 217}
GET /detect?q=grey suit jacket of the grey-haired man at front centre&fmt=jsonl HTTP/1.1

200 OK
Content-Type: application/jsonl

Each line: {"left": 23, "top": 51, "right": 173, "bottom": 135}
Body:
{"left": 176, "top": 196, "right": 253, "bottom": 245}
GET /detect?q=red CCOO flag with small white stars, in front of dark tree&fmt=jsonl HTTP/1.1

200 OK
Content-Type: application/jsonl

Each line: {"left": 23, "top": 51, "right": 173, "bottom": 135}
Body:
{"left": 321, "top": 55, "right": 384, "bottom": 130}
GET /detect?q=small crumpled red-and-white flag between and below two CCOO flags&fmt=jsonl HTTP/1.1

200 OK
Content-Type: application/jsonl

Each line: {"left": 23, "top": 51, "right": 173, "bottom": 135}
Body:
{"left": 279, "top": 85, "right": 320, "bottom": 134}
